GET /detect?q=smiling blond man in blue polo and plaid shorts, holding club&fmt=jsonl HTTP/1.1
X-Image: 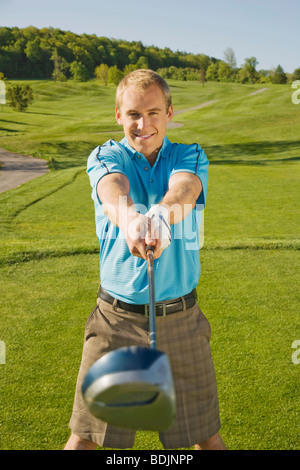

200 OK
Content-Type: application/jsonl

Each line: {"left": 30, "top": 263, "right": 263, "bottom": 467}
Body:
{"left": 65, "top": 70, "right": 225, "bottom": 450}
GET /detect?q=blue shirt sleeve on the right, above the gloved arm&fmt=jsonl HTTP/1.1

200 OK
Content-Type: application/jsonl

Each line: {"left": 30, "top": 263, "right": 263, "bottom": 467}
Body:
{"left": 170, "top": 144, "right": 209, "bottom": 208}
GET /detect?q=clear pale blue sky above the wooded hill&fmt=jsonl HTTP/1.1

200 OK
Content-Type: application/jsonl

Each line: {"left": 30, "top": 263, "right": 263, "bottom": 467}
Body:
{"left": 0, "top": 0, "right": 300, "bottom": 73}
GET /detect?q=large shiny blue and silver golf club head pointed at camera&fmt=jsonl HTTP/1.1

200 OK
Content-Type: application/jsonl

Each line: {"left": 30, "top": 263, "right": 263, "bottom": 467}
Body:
{"left": 81, "top": 346, "right": 175, "bottom": 432}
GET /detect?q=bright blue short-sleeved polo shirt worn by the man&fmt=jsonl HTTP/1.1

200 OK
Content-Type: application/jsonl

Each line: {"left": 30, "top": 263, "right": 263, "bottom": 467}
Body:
{"left": 87, "top": 137, "right": 208, "bottom": 304}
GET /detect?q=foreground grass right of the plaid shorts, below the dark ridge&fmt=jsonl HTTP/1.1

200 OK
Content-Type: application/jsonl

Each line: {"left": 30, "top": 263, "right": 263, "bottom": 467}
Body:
{"left": 199, "top": 249, "right": 300, "bottom": 450}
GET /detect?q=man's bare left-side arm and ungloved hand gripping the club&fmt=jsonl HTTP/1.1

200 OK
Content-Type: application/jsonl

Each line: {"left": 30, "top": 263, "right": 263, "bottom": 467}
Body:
{"left": 97, "top": 173, "right": 162, "bottom": 259}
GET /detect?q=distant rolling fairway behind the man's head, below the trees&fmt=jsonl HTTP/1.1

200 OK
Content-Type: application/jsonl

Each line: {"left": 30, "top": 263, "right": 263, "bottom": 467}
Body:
{"left": 0, "top": 81, "right": 300, "bottom": 169}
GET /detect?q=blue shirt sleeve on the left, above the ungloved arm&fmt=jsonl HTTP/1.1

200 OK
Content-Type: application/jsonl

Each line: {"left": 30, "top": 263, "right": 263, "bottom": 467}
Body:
{"left": 87, "top": 141, "right": 125, "bottom": 204}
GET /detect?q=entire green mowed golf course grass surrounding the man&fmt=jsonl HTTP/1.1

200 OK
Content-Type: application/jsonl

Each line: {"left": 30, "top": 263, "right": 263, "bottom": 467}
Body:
{"left": 0, "top": 81, "right": 300, "bottom": 450}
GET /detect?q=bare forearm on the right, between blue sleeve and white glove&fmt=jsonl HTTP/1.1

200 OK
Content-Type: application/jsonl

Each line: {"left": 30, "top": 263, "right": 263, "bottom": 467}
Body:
{"left": 160, "top": 172, "right": 202, "bottom": 225}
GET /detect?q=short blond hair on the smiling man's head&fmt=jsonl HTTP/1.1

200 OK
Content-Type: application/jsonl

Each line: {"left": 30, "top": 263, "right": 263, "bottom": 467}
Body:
{"left": 116, "top": 69, "right": 172, "bottom": 112}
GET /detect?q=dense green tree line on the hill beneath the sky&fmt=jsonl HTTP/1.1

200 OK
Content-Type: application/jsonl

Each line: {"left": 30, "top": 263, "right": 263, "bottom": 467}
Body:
{"left": 0, "top": 26, "right": 300, "bottom": 85}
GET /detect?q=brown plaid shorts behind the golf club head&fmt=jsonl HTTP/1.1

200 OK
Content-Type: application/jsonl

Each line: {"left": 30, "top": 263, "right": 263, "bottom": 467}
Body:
{"left": 70, "top": 298, "right": 220, "bottom": 449}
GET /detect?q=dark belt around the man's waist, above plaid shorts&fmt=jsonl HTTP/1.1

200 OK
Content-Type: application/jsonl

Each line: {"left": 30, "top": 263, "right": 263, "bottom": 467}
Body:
{"left": 98, "top": 287, "right": 197, "bottom": 317}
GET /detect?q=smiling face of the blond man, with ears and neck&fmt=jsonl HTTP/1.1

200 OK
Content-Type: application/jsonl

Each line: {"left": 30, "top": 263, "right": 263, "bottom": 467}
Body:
{"left": 116, "top": 85, "right": 173, "bottom": 161}
